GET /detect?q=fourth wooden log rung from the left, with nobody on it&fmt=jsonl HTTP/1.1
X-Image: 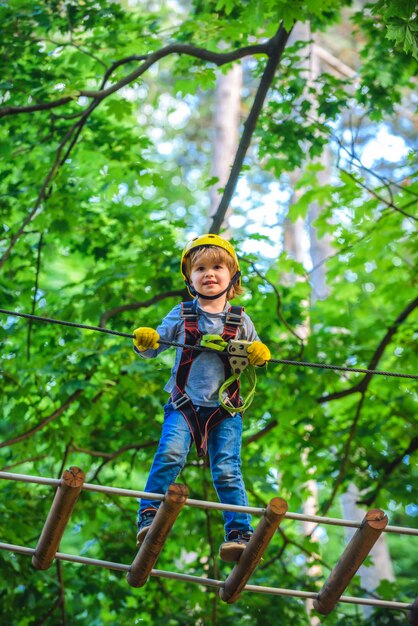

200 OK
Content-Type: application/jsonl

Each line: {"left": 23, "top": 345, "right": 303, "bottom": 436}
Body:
{"left": 313, "top": 509, "right": 388, "bottom": 615}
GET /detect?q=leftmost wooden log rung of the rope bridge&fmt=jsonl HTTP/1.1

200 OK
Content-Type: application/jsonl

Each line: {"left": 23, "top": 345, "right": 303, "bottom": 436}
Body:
{"left": 32, "top": 467, "right": 86, "bottom": 570}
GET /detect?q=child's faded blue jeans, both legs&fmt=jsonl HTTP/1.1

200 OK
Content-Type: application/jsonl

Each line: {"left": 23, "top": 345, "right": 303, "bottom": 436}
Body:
{"left": 138, "top": 403, "right": 253, "bottom": 536}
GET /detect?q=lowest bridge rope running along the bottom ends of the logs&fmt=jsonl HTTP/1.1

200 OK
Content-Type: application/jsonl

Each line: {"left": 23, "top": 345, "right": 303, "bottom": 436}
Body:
{"left": 0, "top": 543, "right": 413, "bottom": 611}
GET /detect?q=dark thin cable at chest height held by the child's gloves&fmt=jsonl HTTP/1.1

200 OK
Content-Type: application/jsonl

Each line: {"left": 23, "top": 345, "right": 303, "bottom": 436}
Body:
{"left": 0, "top": 309, "right": 418, "bottom": 380}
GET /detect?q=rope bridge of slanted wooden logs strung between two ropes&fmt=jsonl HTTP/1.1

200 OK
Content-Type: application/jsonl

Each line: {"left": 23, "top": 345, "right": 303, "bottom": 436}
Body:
{"left": 0, "top": 467, "right": 418, "bottom": 626}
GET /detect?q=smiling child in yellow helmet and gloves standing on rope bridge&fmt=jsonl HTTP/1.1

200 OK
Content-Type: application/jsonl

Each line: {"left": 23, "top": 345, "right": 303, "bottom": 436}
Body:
{"left": 134, "top": 234, "right": 270, "bottom": 561}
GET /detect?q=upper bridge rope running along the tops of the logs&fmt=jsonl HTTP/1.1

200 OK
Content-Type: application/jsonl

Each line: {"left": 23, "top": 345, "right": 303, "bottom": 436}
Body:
{"left": 0, "top": 472, "right": 418, "bottom": 537}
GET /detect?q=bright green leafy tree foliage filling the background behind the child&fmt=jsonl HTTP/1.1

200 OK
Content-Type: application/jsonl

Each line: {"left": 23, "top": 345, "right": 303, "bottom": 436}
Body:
{"left": 0, "top": 0, "right": 418, "bottom": 626}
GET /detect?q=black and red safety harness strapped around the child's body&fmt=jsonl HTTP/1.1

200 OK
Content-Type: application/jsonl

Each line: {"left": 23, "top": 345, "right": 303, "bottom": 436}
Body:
{"left": 171, "top": 301, "right": 244, "bottom": 456}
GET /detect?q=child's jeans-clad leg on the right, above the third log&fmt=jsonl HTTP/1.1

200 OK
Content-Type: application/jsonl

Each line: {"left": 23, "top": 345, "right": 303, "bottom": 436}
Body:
{"left": 208, "top": 414, "right": 253, "bottom": 537}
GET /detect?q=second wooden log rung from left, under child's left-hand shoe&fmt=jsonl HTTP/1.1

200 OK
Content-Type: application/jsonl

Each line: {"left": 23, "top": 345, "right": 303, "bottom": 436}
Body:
{"left": 126, "top": 483, "right": 188, "bottom": 587}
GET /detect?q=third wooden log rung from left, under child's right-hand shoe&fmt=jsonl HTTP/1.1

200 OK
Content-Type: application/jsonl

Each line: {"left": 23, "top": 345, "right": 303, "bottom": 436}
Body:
{"left": 219, "top": 498, "right": 288, "bottom": 604}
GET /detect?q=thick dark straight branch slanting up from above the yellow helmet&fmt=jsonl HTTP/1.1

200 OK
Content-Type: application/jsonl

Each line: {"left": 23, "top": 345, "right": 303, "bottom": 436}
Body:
{"left": 209, "top": 25, "right": 290, "bottom": 233}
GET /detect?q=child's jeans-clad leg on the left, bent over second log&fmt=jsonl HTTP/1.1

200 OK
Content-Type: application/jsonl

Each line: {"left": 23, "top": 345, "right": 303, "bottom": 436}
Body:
{"left": 138, "top": 403, "right": 192, "bottom": 523}
